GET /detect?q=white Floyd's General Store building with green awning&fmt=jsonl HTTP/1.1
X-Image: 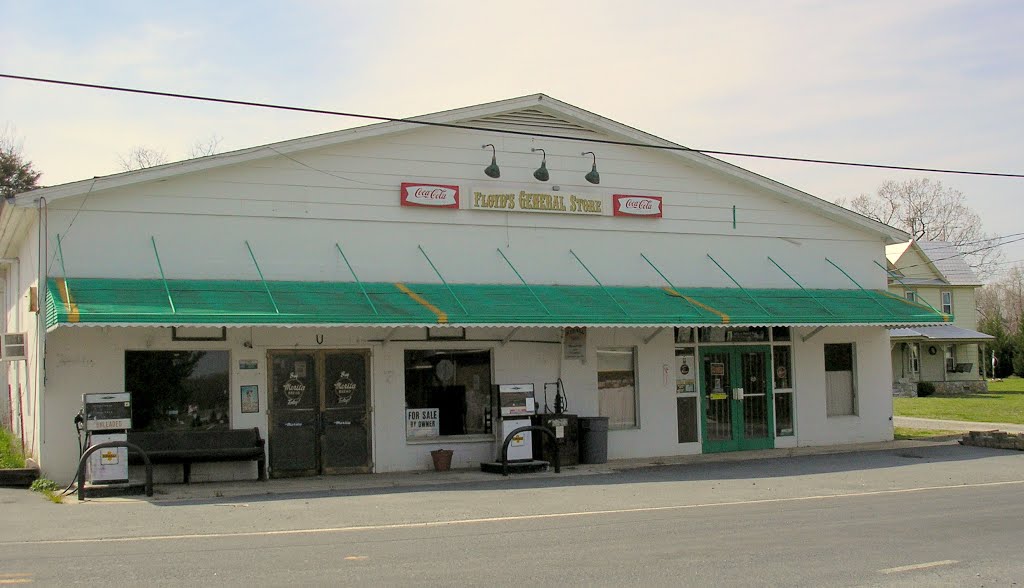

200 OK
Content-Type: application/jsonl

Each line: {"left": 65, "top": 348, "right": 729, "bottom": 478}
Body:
{"left": 0, "top": 94, "right": 948, "bottom": 480}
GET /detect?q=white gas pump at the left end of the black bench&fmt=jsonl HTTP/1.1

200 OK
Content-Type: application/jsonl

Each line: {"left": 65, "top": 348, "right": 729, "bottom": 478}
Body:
{"left": 82, "top": 392, "right": 131, "bottom": 484}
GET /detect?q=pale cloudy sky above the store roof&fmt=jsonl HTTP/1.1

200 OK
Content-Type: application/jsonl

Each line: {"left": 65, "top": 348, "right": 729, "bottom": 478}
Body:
{"left": 6, "top": 0, "right": 1024, "bottom": 278}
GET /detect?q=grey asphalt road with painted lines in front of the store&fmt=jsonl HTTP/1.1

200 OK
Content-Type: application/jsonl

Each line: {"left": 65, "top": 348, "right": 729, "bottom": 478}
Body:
{"left": 0, "top": 445, "right": 1024, "bottom": 586}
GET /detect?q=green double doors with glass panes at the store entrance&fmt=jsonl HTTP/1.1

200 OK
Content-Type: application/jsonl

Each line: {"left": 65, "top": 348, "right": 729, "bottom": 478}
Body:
{"left": 700, "top": 345, "right": 775, "bottom": 453}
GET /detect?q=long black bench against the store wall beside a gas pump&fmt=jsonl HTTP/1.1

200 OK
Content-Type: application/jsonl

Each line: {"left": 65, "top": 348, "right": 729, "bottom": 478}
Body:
{"left": 128, "top": 427, "right": 266, "bottom": 484}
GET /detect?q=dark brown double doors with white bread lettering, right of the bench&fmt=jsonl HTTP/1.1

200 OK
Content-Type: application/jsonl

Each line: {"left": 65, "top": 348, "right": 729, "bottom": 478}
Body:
{"left": 268, "top": 350, "right": 371, "bottom": 477}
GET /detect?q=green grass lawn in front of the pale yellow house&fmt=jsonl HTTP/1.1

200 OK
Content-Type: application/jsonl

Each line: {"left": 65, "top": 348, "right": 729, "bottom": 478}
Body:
{"left": 893, "top": 378, "right": 1024, "bottom": 424}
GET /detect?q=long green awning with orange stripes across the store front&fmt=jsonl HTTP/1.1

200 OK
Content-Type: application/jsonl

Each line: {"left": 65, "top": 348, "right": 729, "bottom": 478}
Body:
{"left": 46, "top": 278, "right": 952, "bottom": 327}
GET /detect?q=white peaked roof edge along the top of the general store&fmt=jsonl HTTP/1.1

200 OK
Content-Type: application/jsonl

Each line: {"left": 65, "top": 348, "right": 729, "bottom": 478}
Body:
{"left": 6, "top": 94, "right": 909, "bottom": 243}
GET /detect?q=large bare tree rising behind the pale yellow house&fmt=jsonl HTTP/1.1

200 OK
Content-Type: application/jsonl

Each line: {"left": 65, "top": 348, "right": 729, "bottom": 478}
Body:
{"left": 841, "top": 178, "right": 1002, "bottom": 280}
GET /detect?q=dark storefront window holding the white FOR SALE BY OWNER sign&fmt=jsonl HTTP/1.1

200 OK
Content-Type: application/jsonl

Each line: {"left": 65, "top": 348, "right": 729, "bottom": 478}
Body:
{"left": 406, "top": 349, "right": 492, "bottom": 438}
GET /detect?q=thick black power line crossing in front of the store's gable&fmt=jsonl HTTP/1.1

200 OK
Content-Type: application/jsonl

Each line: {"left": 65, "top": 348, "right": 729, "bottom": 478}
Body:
{"left": 6, "top": 73, "right": 1024, "bottom": 178}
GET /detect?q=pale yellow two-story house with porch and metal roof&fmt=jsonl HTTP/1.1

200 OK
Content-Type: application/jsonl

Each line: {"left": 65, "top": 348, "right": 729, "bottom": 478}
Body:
{"left": 886, "top": 241, "right": 993, "bottom": 395}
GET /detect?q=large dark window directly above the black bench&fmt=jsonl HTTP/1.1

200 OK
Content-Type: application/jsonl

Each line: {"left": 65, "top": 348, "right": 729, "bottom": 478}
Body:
{"left": 125, "top": 351, "right": 230, "bottom": 431}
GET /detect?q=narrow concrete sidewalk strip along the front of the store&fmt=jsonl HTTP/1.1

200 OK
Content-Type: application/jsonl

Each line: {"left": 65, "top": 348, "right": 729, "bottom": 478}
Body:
{"left": 86, "top": 439, "right": 956, "bottom": 504}
